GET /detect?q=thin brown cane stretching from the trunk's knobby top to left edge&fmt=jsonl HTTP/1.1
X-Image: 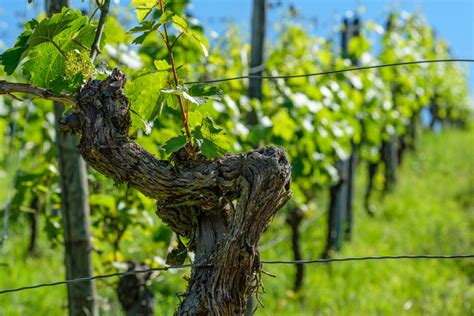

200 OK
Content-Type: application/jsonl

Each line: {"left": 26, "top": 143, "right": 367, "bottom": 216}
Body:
{"left": 0, "top": 80, "right": 77, "bottom": 104}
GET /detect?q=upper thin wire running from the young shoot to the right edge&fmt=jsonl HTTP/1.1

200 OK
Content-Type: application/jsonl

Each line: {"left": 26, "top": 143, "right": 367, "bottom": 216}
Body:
{"left": 184, "top": 59, "right": 474, "bottom": 85}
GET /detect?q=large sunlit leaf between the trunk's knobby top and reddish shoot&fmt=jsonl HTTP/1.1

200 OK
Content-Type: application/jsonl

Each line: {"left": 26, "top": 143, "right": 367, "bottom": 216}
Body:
{"left": 125, "top": 72, "right": 167, "bottom": 131}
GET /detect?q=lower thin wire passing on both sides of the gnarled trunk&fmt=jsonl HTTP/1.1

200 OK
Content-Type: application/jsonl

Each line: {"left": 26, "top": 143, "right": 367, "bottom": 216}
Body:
{"left": 0, "top": 254, "right": 474, "bottom": 294}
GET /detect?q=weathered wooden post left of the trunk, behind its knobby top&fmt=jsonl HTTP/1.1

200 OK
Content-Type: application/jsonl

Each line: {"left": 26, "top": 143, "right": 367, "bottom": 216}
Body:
{"left": 46, "top": 0, "right": 98, "bottom": 316}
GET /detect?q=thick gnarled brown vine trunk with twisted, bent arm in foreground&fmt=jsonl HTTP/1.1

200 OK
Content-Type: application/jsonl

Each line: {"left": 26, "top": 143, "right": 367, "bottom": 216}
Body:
{"left": 63, "top": 69, "right": 290, "bottom": 315}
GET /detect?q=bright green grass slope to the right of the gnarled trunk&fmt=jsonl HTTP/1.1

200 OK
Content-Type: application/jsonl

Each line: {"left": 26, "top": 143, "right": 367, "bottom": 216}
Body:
{"left": 259, "top": 131, "right": 474, "bottom": 315}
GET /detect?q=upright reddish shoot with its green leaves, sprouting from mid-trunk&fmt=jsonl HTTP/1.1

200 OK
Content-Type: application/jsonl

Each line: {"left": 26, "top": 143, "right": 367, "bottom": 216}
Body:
{"left": 125, "top": 0, "right": 228, "bottom": 159}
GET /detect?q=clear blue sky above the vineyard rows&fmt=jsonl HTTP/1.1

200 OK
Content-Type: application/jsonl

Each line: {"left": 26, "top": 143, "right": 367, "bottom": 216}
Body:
{"left": 0, "top": 0, "right": 474, "bottom": 94}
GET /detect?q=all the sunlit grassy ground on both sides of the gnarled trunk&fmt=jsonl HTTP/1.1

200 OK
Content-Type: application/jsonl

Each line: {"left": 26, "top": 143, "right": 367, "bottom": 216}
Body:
{"left": 0, "top": 127, "right": 474, "bottom": 316}
